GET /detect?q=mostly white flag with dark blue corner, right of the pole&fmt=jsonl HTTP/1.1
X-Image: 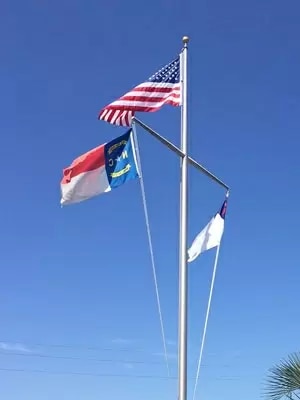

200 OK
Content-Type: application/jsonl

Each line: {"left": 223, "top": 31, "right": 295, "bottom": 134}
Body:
{"left": 188, "top": 199, "right": 227, "bottom": 262}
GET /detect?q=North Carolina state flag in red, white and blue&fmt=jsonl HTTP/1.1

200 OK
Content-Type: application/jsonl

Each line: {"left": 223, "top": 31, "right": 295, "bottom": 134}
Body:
{"left": 60, "top": 129, "right": 139, "bottom": 205}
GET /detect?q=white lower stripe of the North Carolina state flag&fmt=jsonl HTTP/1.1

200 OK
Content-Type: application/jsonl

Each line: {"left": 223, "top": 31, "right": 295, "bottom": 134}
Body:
{"left": 61, "top": 166, "right": 111, "bottom": 204}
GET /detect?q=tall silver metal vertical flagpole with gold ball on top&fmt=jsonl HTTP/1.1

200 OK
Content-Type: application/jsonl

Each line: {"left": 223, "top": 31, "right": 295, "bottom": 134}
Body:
{"left": 178, "top": 36, "right": 189, "bottom": 400}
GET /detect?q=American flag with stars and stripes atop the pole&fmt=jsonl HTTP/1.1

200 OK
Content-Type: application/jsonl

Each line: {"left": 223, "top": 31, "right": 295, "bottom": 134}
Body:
{"left": 98, "top": 56, "right": 181, "bottom": 126}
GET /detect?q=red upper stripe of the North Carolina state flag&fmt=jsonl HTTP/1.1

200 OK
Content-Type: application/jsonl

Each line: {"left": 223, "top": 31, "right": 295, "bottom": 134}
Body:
{"left": 61, "top": 144, "right": 105, "bottom": 184}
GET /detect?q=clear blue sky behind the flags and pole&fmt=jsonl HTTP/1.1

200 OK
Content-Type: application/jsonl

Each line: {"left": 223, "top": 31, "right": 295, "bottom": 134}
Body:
{"left": 0, "top": 0, "right": 300, "bottom": 400}
